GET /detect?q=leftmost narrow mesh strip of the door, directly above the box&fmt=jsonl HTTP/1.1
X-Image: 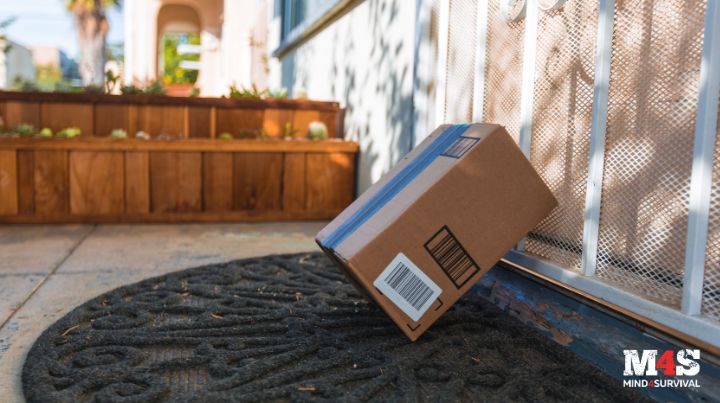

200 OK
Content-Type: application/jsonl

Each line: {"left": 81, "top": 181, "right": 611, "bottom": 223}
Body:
{"left": 445, "top": 0, "right": 478, "bottom": 123}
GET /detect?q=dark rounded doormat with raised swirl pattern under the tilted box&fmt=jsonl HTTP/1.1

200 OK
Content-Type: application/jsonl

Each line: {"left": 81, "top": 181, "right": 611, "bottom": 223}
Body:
{"left": 22, "top": 253, "right": 643, "bottom": 403}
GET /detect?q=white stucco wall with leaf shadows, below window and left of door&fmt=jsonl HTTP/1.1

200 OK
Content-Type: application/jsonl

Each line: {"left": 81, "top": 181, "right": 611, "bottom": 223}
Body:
{"left": 281, "top": 0, "right": 415, "bottom": 192}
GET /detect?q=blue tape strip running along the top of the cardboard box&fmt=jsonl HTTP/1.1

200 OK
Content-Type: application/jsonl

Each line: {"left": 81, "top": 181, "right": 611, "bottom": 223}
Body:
{"left": 323, "top": 124, "right": 470, "bottom": 249}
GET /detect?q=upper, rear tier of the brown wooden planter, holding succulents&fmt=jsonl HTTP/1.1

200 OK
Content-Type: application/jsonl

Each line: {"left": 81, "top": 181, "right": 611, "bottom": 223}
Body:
{"left": 0, "top": 91, "right": 343, "bottom": 139}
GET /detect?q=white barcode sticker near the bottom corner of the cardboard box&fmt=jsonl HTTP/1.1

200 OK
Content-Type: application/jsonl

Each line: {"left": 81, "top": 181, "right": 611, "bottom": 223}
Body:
{"left": 373, "top": 253, "right": 442, "bottom": 322}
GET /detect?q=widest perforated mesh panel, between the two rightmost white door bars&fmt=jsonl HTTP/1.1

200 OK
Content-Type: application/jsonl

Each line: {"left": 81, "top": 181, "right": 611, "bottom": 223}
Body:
{"left": 597, "top": 0, "right": 705, "bottom": 307}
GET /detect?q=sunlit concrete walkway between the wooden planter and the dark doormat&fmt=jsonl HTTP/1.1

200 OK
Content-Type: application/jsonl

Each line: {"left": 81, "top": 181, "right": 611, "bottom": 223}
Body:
{"left": 0, "top": 222, "right": 324, "bottom": 403}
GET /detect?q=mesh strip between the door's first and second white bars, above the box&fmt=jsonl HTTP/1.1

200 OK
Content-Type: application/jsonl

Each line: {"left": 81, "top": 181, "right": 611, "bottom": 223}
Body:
{"left": 483, "top": 1, "right": 525, "bottom": 140}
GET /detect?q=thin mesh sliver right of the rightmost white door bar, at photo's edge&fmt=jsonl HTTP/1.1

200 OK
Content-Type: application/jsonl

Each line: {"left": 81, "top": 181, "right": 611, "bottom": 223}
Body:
{"left": 702, "top": 96, "right": 720, "bottom": 320}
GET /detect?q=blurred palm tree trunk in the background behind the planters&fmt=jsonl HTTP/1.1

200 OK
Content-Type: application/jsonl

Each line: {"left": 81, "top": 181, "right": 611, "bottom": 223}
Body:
{"left": 66, "top": 0, "right": 120, "bottom": 87}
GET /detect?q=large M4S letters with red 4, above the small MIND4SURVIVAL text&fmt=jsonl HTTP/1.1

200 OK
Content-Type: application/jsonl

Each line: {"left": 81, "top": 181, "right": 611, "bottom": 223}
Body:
{"left": 623, "top": 349, "right": 700, "bottom": 376}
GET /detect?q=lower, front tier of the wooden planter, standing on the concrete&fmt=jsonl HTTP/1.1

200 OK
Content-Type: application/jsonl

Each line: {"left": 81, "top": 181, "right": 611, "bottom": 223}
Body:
{"left": 0, "top": 138, "right": 358, "bottom": 223}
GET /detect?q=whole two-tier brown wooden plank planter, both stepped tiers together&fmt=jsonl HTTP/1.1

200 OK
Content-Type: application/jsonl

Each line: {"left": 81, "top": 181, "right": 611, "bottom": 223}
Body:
{"left": 0, "top": 91, "right": 358, "bottom": 223}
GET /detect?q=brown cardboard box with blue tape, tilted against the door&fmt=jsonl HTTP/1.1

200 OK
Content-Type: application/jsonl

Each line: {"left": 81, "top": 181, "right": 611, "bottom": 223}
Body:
{"left": 316, "top": 124, "right": 557, "bottom": 341}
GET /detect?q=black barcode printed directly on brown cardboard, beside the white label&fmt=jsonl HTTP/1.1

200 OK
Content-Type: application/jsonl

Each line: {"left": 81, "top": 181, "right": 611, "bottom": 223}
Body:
{"left": 425, "top": 225, "right": 479, "bottom": 288}
